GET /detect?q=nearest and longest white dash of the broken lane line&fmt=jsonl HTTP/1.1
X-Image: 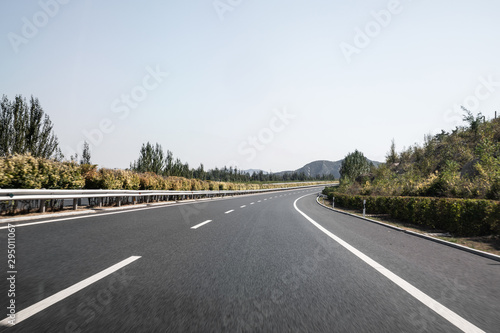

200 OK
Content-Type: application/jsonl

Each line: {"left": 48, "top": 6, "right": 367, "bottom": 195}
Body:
{"left": 0, "top": 256, "right": 141, "bottom": 326}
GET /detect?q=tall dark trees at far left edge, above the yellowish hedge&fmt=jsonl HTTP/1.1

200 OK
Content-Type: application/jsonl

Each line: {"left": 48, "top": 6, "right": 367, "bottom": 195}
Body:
{"left": 0, "top": 95, "right": 62, "bottom": 159}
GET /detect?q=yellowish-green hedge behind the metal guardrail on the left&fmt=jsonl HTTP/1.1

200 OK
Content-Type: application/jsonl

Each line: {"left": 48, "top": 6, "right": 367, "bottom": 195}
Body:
{"left": 0, "top": 155, "right": 328, "bottom": 191}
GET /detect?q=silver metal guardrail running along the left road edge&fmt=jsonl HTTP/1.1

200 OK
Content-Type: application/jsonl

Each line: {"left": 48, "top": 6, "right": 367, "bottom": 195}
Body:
{"left": 0, "top": 184, "right": 329, "bottom": 212}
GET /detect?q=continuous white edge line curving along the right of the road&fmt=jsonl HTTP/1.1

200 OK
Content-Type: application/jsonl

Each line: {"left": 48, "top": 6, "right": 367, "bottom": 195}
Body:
{"left": 293, "top": 194, "right": 484, "bottom": 333}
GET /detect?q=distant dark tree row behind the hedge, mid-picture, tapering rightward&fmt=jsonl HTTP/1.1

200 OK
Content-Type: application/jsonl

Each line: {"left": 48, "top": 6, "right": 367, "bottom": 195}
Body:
{"left": 130, "top": 142, "right": 333, "bottom": 182}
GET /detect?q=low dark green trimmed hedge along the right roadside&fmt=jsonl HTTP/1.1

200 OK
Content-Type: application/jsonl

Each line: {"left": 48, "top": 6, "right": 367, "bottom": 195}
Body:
{"left": 323, "top": 190, "right": 500, "bottom": 236}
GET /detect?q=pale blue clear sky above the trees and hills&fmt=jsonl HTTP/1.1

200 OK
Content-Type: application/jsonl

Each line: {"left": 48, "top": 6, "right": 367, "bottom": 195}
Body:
{"left": 0, "top": 0, "right": 500, "bottom": 171}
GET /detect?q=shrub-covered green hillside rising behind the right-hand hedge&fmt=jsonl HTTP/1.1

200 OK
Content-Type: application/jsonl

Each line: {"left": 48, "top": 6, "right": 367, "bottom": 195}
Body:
{"left": 339, "top": 109, "right": 500, "bottom": 200}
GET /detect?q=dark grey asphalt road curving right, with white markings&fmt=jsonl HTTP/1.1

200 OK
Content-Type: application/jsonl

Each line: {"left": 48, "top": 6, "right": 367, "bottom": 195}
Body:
{"left": 0, "top": 188, "right": 500, "bottom": 332}
